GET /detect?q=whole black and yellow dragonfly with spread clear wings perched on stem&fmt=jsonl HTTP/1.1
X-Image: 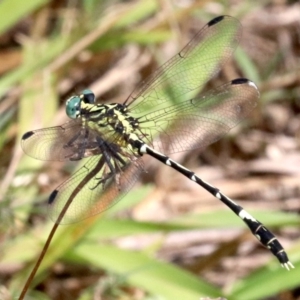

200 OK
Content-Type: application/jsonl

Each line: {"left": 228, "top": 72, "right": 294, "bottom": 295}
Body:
{"left": 22, "top": 16, "right": 294, "bottom": 300}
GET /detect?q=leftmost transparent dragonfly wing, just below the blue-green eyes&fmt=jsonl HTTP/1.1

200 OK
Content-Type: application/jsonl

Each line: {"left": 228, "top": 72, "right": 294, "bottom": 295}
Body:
{"left": 21, "top": 119, "right": 99, "bottom": 161}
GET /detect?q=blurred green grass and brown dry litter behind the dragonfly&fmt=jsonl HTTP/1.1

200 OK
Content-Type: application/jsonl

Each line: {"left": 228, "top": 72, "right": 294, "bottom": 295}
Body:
{"left": 0, "top": 0, "right": 300, "bottom": 300}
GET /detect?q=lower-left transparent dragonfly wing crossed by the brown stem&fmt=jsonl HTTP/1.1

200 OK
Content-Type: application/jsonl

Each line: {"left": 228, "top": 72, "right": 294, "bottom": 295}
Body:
{"left": 49, "top": 155, "right": 143, "bottom": 224}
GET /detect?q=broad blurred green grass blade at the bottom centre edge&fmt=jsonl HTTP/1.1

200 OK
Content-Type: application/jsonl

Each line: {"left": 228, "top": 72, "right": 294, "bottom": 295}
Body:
{"left": 71, "top": 243, "right": 222, "bottom": 300}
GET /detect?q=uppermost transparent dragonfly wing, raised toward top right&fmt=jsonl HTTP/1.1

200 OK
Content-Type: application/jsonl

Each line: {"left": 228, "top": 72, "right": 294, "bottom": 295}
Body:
{"left": 125, "top": 16, "right": 242, "bottom": 117}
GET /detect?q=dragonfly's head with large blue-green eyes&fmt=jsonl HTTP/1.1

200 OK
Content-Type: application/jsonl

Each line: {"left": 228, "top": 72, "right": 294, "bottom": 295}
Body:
{"left": 66, "top": 90, "right": 95, "bottom": 119}
